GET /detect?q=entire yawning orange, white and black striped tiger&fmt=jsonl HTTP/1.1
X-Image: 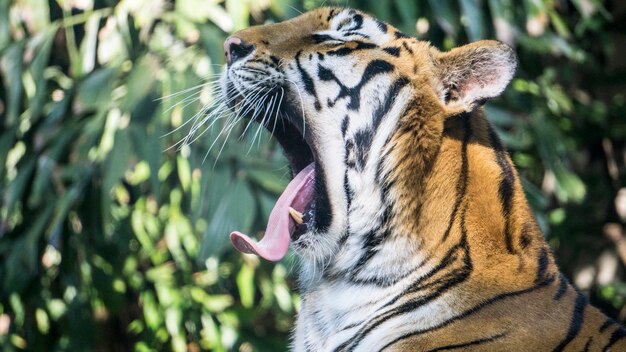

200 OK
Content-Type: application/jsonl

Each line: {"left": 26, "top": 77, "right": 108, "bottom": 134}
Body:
{"left": 221, "top": 8, "right": 626, "bottom": 351}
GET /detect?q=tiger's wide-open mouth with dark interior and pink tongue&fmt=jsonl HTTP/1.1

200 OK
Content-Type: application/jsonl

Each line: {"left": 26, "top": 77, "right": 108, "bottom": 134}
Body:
{"left": 224, "top": 80, "right": 329, "bottom": 261}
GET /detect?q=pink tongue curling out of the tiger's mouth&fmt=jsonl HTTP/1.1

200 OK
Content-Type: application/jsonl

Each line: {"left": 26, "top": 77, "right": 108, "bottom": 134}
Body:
{"left": 230, "top": 163, "right": 315, "bottom": 261}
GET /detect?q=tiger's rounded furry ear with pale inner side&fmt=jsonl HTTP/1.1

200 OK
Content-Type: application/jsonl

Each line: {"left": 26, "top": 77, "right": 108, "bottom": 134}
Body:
{"left": 435, "top": 40, "right": 517, "bottom": 110}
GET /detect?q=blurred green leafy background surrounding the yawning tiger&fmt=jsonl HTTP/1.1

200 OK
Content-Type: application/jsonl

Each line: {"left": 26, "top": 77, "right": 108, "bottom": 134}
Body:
{"left": 0, "top": 0, "right": 626, "bottom": 351}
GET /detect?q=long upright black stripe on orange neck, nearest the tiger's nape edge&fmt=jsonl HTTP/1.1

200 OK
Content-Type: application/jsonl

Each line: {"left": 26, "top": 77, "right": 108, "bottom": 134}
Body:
{"left": 488, "top": 126, "right": 515, "bottom": 253}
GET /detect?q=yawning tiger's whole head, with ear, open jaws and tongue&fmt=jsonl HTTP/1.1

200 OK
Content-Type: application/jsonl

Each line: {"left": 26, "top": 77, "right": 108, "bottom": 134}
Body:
{"left": 221, "top": 8, "right": 516, "bottom": 272}
